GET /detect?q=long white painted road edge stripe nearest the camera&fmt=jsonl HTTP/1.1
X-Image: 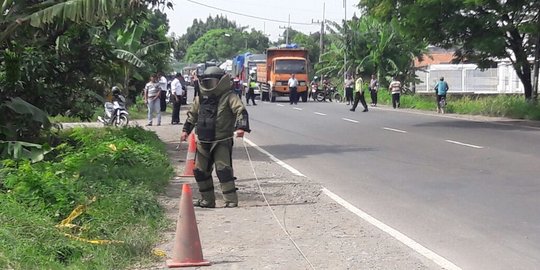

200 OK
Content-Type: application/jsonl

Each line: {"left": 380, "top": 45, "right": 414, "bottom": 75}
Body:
{"left": 322, "top": 188, "right": 461, "bottom": 270}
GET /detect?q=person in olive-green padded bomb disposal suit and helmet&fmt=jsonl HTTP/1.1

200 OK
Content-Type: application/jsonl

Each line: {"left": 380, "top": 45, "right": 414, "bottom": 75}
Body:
{"left": 180, "top": 67, "right": 251, "bottom": 208}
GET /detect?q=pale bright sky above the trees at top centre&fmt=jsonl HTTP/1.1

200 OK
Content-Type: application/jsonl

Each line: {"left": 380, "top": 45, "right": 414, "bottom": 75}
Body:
{"left": 165, "top": 0, "right": 358, "bottom": 41}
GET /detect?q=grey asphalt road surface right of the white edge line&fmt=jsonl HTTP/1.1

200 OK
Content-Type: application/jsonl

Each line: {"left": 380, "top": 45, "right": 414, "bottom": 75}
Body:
{"left": 244, "top": 98, "right": 540, "bottom": 269}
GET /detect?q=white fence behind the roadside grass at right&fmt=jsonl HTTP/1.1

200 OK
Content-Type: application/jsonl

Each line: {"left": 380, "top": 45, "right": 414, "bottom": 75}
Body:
{"left": 416, "top": 62, "right": 523, "bottom": 94}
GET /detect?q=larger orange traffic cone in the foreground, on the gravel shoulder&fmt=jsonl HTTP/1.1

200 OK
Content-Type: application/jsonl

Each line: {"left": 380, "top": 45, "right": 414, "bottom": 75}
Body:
{"left": 167, "top": 184, "right": 210, "bottom": 268}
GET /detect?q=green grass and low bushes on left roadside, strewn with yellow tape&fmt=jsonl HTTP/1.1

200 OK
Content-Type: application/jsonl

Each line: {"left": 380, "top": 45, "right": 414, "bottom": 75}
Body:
{"left": 0, "top": 127, "right": 172, "bottom": 269}
